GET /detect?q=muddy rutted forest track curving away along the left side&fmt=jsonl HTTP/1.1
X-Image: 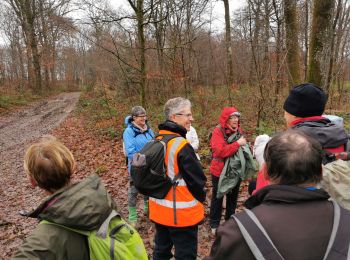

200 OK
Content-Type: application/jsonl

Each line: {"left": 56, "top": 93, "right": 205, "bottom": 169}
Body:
{"left": 0, "top": 92, "right": 80, "bottom": 259}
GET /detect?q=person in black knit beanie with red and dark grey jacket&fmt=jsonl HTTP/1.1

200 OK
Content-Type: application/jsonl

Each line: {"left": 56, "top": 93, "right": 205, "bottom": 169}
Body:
{"left": 252, "top": 83, "right": 349, "bottom": 194}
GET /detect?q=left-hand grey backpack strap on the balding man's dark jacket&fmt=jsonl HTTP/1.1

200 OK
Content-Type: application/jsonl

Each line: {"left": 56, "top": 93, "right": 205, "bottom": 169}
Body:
{"left": 232, "top": 209, "right": 284, "bottom": 260}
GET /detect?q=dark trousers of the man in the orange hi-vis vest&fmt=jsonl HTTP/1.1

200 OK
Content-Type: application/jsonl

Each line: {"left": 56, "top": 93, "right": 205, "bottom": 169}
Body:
{"left": 153, "top": 223, "right": 198, "bottom": 260}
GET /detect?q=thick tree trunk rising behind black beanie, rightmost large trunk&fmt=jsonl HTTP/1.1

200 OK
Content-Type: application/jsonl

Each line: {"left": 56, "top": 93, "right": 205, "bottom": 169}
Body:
{"left": 307, "top": 0, "right": 335, "bottom": 87}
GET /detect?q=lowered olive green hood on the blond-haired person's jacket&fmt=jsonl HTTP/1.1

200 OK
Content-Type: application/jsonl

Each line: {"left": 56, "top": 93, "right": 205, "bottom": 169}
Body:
{"left": 28, "top": 174, "right": 116, "bottom": 230}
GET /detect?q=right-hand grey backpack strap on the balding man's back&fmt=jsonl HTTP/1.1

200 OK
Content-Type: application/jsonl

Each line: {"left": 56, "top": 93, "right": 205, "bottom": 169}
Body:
{"left": 323, "top": 199, "right": 350, "bottom": 260}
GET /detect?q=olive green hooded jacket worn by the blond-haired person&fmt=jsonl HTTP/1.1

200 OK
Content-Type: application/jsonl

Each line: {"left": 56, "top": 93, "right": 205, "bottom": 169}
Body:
{"left": 12, "top": 175, "right": 116, "bottom": 260}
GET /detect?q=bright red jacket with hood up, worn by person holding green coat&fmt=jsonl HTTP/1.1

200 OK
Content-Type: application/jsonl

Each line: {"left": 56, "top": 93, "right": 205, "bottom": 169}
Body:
{"left": 210, "top": 107, "right": 240, "bottom": 177}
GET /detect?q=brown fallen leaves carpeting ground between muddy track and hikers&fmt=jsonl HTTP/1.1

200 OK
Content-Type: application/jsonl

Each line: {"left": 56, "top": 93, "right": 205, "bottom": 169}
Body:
{"left": 53, "top": 117, "right": 248, "bottom": 258}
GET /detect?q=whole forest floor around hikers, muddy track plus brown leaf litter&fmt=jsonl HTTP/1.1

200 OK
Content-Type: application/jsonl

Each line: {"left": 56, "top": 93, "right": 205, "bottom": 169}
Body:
{"left": 0, "top": 93, "right": 252, "bottom": 259}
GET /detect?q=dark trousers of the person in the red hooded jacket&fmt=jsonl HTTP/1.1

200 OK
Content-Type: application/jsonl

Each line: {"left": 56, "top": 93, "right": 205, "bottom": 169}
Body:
{"left": 210, "top": 175, "right": 241, "bottom": 228}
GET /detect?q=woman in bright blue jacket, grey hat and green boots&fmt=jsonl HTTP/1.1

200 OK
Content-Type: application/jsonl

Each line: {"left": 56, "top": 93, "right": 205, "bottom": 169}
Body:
{"left": 123, "top": 106, "right": 154, "bottom": 226}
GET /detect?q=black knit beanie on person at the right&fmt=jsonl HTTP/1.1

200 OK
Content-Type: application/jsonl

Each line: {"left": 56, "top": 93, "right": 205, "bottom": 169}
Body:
{"left": 283, "top": 83, "right": 327, "bottom": 117}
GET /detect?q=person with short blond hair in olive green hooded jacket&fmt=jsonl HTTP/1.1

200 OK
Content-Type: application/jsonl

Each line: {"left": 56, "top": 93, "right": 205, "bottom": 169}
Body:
{"left": 13, "top": 139, "right": 116, "bottom": 260}
